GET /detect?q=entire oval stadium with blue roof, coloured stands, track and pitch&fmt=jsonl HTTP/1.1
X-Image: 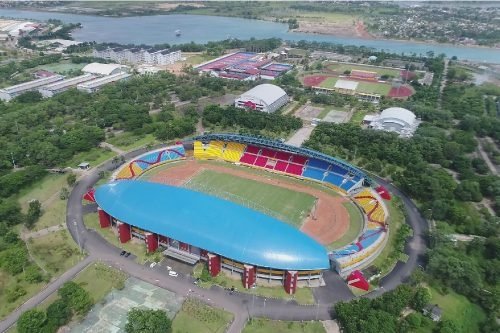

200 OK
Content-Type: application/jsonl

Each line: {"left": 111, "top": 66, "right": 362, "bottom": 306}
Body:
{"left": 92, "top": 134, "right": 390, "bottom": 294}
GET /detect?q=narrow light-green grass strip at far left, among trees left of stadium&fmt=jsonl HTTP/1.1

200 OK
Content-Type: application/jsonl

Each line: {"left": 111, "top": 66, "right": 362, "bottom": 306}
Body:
{"left": 17, "top": 174, "right": 68, "bottom": 213}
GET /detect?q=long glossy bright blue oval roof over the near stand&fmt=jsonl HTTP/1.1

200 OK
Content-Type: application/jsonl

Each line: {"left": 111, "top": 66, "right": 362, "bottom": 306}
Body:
{"left": 95, "top": 180, "right": 330, "bottom": 270}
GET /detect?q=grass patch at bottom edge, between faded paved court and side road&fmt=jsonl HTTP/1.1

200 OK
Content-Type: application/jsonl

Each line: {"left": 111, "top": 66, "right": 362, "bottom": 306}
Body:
{"left": 172, "top": 298, "right": 233, "bottom": 333}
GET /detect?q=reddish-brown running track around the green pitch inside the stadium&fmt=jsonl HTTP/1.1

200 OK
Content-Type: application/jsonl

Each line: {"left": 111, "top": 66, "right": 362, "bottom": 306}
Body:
{"left": 150, "top": 160, "right": 350, "bottom": 245}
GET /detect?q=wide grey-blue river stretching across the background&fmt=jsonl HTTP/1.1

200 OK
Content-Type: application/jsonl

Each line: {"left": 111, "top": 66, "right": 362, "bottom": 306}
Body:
{"left": 0, "top": 9, "right": 500, "bottom": 63}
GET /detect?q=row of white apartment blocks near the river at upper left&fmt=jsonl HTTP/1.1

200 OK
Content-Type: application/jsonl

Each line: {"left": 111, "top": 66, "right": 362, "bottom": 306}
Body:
{"left": 93, "top": 47, "right": 182, "bottom": 65}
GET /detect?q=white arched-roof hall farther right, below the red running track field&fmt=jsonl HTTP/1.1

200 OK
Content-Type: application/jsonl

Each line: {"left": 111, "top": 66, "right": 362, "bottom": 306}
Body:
{"left": 364, "top": 107, "right": 421, "bottom": 138}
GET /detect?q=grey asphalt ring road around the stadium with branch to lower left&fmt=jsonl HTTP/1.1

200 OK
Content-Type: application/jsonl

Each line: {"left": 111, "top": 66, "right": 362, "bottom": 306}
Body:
{"left": 0, "top": 145, "right": 427, "bottom": 333}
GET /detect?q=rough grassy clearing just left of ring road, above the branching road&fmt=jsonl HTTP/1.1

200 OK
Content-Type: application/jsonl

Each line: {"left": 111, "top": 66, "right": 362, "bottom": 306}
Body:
{"left": 27, "top": 230, "right": 80, "bottom": 275}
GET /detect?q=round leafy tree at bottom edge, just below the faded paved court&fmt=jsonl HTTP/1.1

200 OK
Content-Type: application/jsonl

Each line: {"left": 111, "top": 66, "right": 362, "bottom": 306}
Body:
{"left": 125, "top": 308, "right": 172, "bottom": 333}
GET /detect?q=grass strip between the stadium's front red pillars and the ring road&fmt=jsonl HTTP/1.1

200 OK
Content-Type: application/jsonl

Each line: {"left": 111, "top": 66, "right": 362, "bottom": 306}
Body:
{"left": 193, "top": 264, "right": 314, "bottom": 304}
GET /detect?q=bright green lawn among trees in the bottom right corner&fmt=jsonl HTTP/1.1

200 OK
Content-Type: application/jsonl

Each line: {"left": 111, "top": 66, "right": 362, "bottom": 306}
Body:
{"left": 430, "top": 288, "right": 486, "bottom": 333}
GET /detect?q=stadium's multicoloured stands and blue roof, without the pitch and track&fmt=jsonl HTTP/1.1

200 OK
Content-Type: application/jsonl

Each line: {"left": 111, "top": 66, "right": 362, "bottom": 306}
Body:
{"left": 91, "top": 134, "right": 390, "bottom": 294}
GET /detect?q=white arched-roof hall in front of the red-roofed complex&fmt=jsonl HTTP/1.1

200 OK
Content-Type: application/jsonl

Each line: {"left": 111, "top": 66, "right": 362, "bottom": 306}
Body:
{"left": 234, "top": 83, "right": 289, "bottom": 113}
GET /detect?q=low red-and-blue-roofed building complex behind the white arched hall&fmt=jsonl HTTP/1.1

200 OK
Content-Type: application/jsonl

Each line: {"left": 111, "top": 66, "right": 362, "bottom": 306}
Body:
{"left": 195, "top": 52, "right": 293, "bottom": 81}
